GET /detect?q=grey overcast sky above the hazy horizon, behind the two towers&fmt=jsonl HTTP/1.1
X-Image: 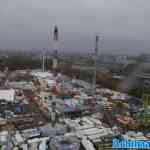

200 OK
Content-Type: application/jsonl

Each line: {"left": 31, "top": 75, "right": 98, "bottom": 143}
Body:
{"left": 0, "top": 0, "right": 150, "bottom": 53}
